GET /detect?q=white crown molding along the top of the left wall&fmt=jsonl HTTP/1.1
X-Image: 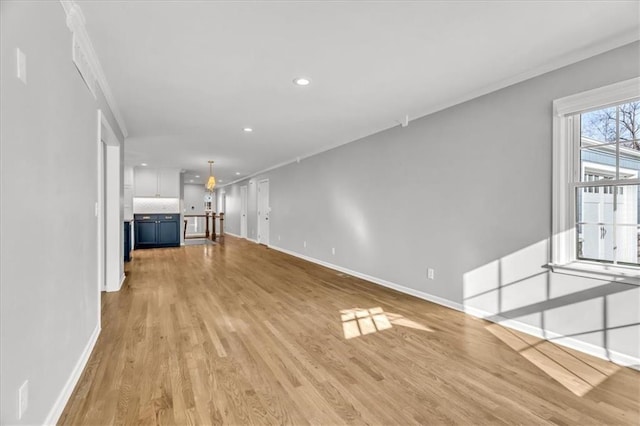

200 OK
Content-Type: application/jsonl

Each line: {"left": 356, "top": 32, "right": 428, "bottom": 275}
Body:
{"left": 60, "top": 0, "right": 129, "bottom": 138}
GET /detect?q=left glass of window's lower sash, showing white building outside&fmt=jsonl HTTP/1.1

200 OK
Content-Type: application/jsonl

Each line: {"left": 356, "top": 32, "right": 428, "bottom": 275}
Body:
{"left": 576, "top": 186, "right": 615, "bottom": 261}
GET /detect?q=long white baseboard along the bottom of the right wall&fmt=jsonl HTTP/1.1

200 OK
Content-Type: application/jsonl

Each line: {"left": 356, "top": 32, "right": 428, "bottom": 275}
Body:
{"left": 269, "top": 246, "right": 640, "bottom": 370}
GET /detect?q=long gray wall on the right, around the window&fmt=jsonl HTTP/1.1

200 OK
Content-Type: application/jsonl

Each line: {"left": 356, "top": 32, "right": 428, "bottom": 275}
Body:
{"left": 223, "top": 42, "right": 640, "bottom": 358}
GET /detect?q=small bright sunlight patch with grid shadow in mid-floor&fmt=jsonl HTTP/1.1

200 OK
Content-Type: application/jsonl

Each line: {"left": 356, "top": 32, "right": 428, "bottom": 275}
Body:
{"left": 340, "top": 307, "right": 433, "bottom": 339}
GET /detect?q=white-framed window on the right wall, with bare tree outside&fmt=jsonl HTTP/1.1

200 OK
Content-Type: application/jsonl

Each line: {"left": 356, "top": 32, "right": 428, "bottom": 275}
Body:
{"left": 551, "top": 78, "right": 640, "bottom": 285}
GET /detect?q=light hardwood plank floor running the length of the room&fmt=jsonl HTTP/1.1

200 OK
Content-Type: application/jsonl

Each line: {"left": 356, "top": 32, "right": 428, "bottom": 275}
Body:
{"left": 60, "top": 237, "right": 640, "bottom": 425}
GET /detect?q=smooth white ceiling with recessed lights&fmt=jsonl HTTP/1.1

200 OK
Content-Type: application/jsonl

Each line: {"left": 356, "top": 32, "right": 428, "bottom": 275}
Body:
{"left": 78, "top": 1, "right": 640, "bottom": 183}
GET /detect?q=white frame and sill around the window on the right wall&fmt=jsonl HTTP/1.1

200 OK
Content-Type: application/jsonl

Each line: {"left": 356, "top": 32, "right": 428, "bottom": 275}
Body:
{"left": 550, "top": 77, "right": 640, "bottom": 285}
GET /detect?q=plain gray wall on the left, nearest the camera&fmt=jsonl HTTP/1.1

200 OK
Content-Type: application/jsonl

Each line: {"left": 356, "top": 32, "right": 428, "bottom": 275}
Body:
{"left": 0, "top": 1, "right": 122, "bottom": 424}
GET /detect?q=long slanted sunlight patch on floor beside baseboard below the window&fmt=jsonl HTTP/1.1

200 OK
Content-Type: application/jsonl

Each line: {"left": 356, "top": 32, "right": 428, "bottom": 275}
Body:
{"left": 486, "top": 324, "right": 620, "bottom": 396}
